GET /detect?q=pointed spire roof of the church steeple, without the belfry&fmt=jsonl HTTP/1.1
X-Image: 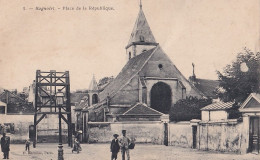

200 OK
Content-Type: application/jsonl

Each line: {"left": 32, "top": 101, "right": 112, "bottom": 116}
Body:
{"left": 126, "top": 4, "right": 156, "bottom": 48}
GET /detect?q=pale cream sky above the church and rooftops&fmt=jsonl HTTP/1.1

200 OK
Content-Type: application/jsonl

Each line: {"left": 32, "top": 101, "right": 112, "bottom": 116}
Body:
{"left": 0, "top": 0, "right": 260, "bottom": 90}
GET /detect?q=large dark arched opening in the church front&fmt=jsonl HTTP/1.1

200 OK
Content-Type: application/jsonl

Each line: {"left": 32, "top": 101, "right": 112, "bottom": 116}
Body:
{"left": 150, "top": 82, "right": 172, "bottom": 114}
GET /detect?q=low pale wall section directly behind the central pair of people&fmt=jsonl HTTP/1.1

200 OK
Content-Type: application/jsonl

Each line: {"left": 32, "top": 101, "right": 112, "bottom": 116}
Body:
{"left": 88, "top": 122, "right": 164, "bottom": 144}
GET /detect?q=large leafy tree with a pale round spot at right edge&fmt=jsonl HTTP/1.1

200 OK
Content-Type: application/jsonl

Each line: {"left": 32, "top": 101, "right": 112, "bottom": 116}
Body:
{"left": 217, "top": 48, "right": 260, "bottom": 103}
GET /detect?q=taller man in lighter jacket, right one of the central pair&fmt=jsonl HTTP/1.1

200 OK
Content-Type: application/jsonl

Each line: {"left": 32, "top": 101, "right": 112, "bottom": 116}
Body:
{"left": 120, "top": 130, "right": 130, "bottom": 160}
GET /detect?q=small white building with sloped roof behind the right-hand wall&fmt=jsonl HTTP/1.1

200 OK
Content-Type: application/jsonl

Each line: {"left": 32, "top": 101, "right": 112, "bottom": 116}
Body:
{"left": 201, "top": 101, "right": 234, "bottom": 121}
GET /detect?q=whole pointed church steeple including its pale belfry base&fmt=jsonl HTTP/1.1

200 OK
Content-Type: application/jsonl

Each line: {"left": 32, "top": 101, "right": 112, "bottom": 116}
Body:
{"left": 126, "top": 0, "right": 158, "bottom": 59}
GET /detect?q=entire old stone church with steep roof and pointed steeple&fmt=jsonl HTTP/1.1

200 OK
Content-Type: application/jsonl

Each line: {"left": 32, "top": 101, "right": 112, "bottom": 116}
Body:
{"left": 82, "top": 1, "right": 204, "bottom": 121}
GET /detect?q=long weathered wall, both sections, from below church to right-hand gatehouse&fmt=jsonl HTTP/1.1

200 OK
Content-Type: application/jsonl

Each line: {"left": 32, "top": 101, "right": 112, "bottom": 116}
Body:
{"left": 87, "top": 120, "right": 248, "bottom": 154}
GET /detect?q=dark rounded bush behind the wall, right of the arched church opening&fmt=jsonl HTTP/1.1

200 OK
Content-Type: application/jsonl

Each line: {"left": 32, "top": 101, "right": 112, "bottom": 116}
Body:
{"left": 170, "top": 97, "right": 212, "bottom": 121}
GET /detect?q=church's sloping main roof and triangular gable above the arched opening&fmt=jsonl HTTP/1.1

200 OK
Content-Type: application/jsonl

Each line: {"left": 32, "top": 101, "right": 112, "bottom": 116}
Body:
{"left": 99, "top": 45, "right": 204, "bottom": 102}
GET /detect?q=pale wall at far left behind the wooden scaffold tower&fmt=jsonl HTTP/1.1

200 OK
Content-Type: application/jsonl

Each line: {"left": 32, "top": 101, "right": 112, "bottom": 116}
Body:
{"left": 0, "top": 114, "right": 68, "bottom": 143}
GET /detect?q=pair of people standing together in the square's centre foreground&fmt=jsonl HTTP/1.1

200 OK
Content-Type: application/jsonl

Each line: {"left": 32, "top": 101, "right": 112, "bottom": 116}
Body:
{"left": 110, "top": 130, "right": 134, "bottom": 160}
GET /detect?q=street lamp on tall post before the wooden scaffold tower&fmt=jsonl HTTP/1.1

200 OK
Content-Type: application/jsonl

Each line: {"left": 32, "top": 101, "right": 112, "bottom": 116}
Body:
{"left": 56, "top": 89, "right": 64, "bottom": 160}
